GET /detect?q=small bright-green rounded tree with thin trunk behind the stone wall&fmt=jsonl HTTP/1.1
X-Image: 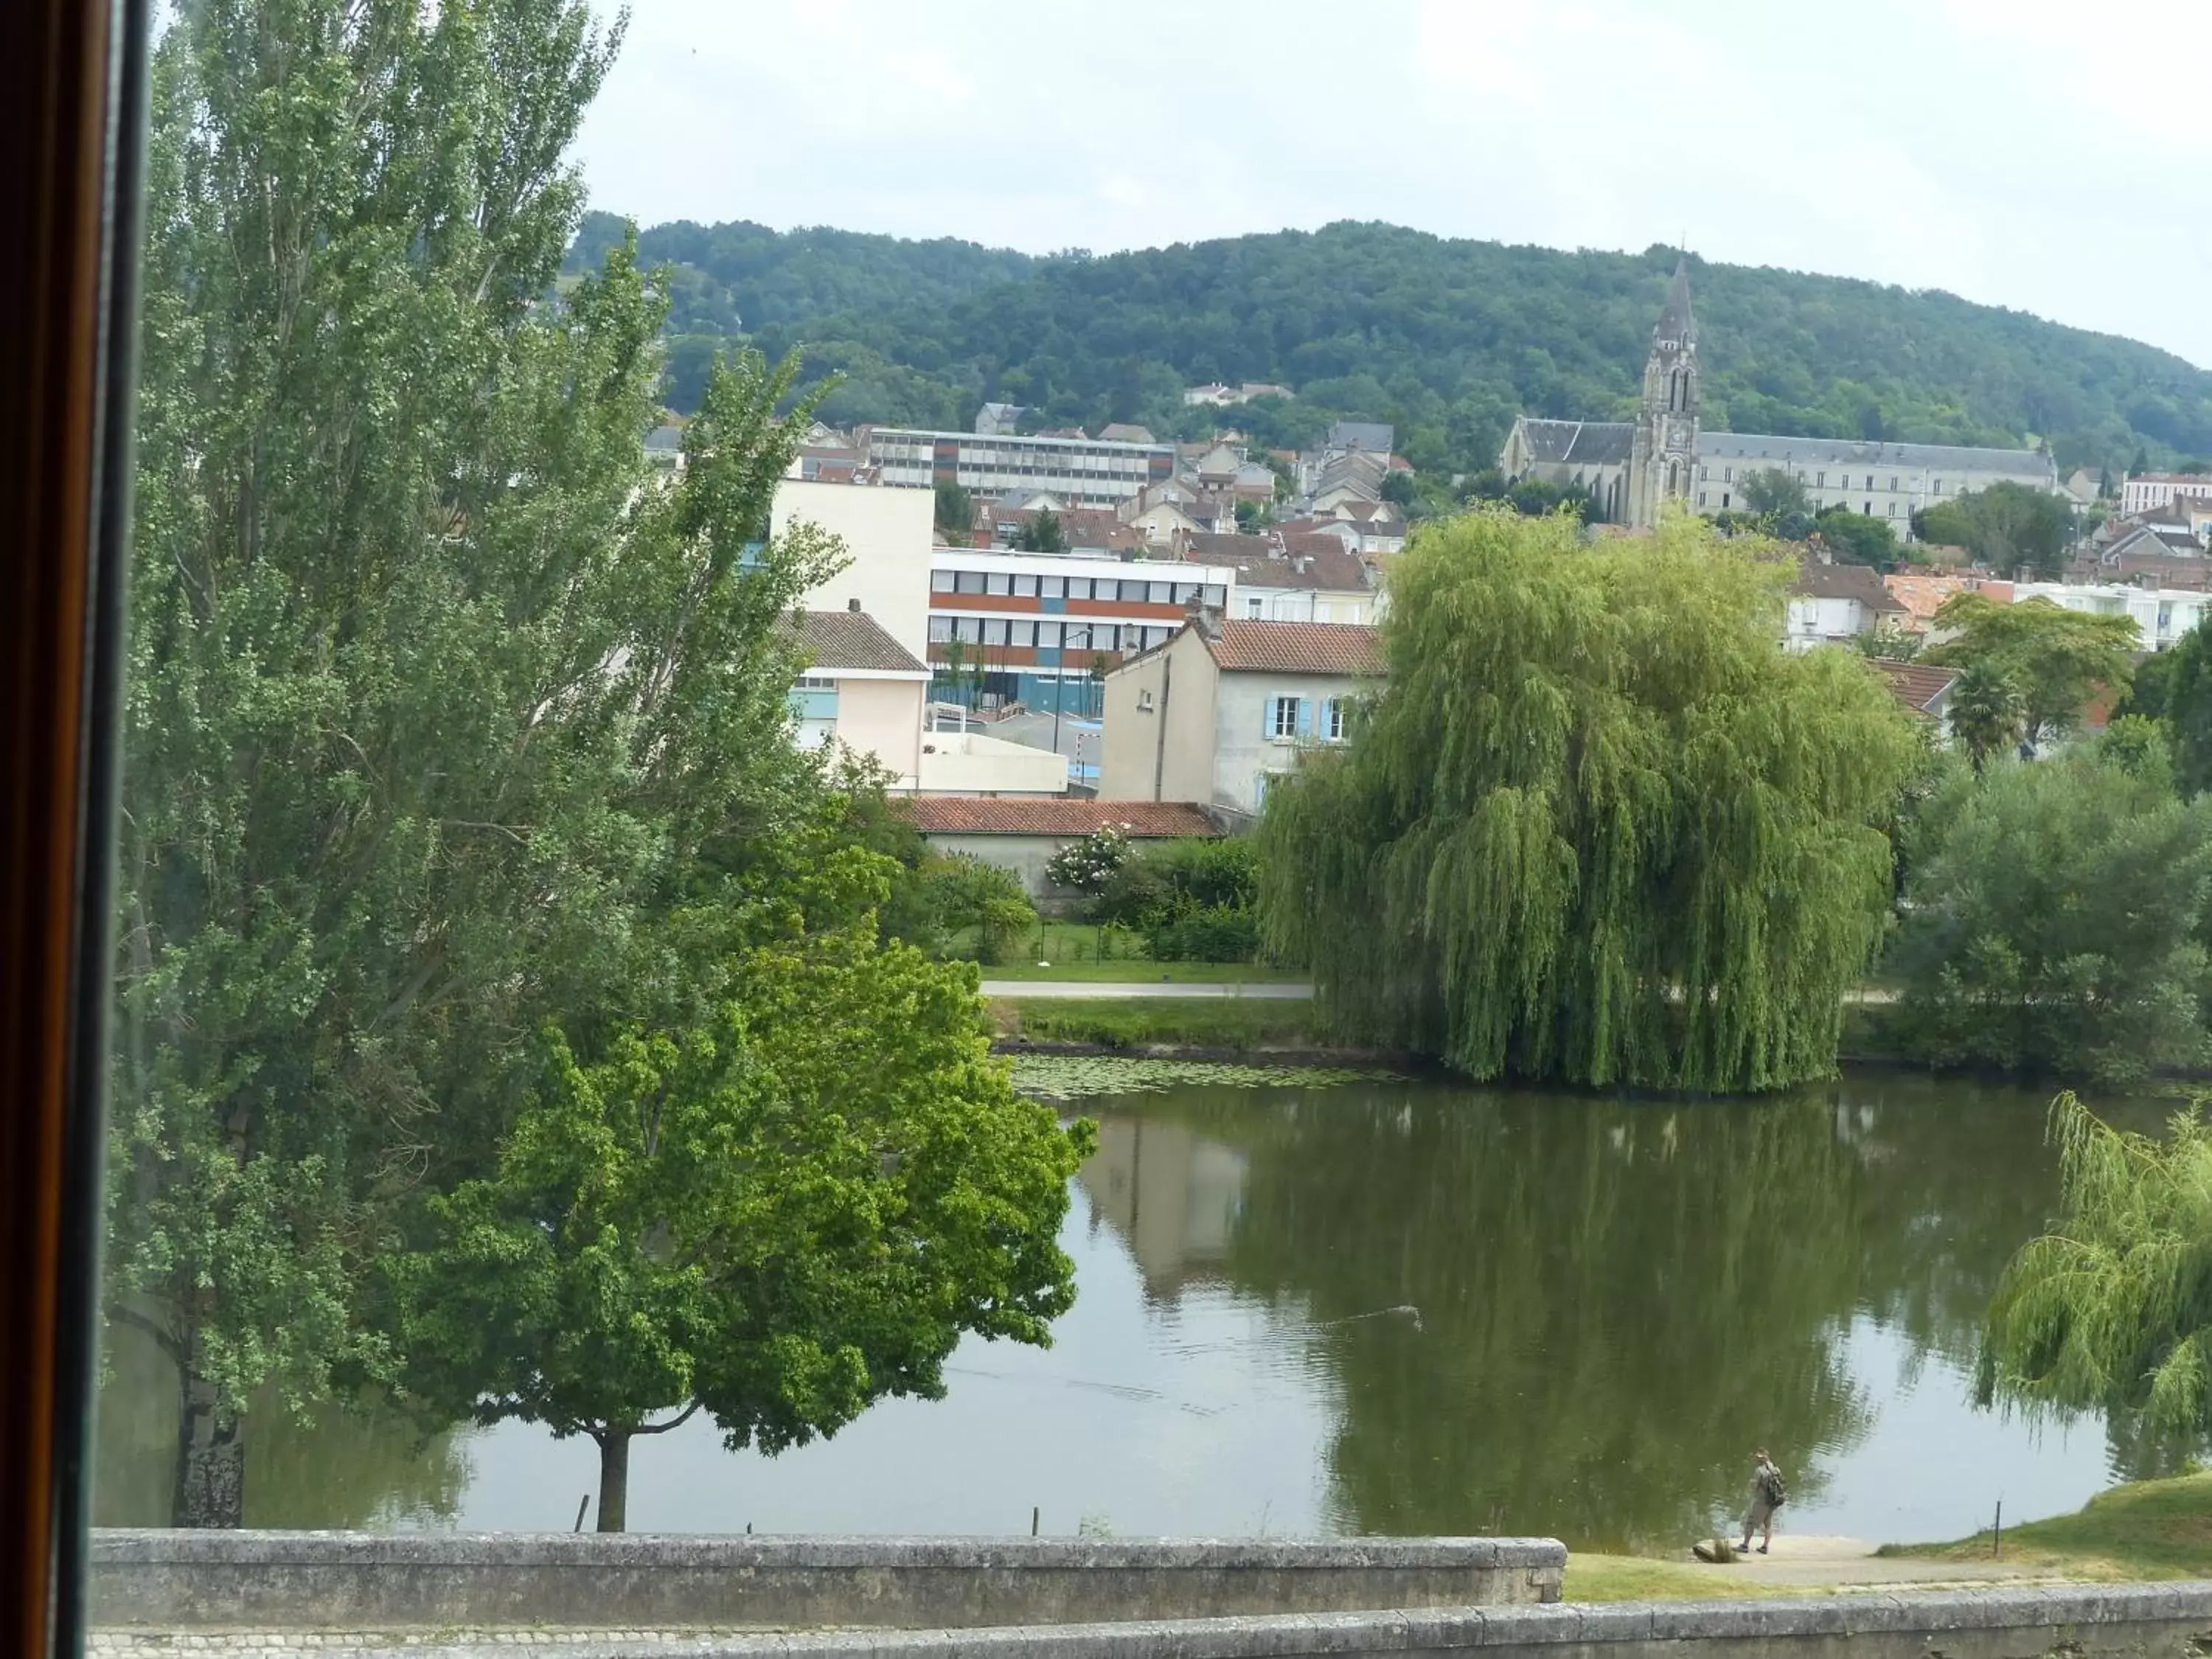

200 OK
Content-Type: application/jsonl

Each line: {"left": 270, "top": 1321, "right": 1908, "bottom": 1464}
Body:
{"left": 387, "top": 925, "right": 1091, "bottom": 1533}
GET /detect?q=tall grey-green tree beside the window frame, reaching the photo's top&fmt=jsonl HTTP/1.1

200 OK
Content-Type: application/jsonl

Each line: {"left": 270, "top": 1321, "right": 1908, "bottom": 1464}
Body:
{"left": 106, "top": 0, "right": 880, "bottom": 1526}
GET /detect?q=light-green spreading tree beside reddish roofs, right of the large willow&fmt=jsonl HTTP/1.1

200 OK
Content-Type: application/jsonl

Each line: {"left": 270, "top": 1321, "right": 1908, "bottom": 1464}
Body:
{"left": 1927, "top": 591, "right": 2137, "bottom": 752}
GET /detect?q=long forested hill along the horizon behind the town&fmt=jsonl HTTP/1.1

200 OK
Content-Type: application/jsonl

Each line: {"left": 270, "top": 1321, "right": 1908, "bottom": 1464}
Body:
{"left": 571, "top": 215, "right": 2212, "bottom": 473}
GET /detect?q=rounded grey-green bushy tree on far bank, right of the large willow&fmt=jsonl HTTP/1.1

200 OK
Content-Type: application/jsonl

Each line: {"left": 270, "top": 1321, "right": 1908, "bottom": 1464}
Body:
{"left": 1887, "top": 743, "right": 2212, "bottom": 1084}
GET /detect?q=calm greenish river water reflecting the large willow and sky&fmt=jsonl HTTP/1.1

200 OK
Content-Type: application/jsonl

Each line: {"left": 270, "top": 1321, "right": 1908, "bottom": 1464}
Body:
{"left": 97, "top": 1075, "right": 2157, "bottom": 1548}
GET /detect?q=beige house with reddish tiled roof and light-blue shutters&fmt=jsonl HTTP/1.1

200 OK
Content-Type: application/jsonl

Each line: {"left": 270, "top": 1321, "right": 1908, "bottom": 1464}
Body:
{"left": 1099, "top": 613, "right": 1382, "bottom": 816}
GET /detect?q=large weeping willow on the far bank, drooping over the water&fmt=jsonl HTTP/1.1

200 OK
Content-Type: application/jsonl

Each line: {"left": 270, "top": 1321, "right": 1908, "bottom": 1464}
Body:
{"left": 1259, "top": 511, "right": 1918, "bottom": 1091}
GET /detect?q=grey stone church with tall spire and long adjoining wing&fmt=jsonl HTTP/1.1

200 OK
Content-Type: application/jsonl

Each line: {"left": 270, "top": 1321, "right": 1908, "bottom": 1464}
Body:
{"left": 1498, "top": 254, "right": 2059, "bottom": 535}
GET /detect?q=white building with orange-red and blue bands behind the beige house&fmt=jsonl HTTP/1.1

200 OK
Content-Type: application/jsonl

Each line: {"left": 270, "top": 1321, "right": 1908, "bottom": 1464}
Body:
{"left": 929, "top": 546, "right": 1237, "bottom": 714}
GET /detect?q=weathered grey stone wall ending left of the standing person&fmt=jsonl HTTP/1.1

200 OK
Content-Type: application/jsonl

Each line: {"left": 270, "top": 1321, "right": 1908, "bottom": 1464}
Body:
{"left": 91, "top": 1531, "right": 1566, "bottom": 1632}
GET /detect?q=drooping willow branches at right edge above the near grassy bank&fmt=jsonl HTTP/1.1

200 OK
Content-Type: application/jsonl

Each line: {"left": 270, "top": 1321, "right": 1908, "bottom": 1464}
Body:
{"left": 1980, "top": 1093, "right": 2212, "bottom": 1440}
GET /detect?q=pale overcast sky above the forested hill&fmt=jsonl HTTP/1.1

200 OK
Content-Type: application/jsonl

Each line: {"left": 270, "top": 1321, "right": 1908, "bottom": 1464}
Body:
{"left": 582, "top": 0, "right": 2212, "bottom": 367}
